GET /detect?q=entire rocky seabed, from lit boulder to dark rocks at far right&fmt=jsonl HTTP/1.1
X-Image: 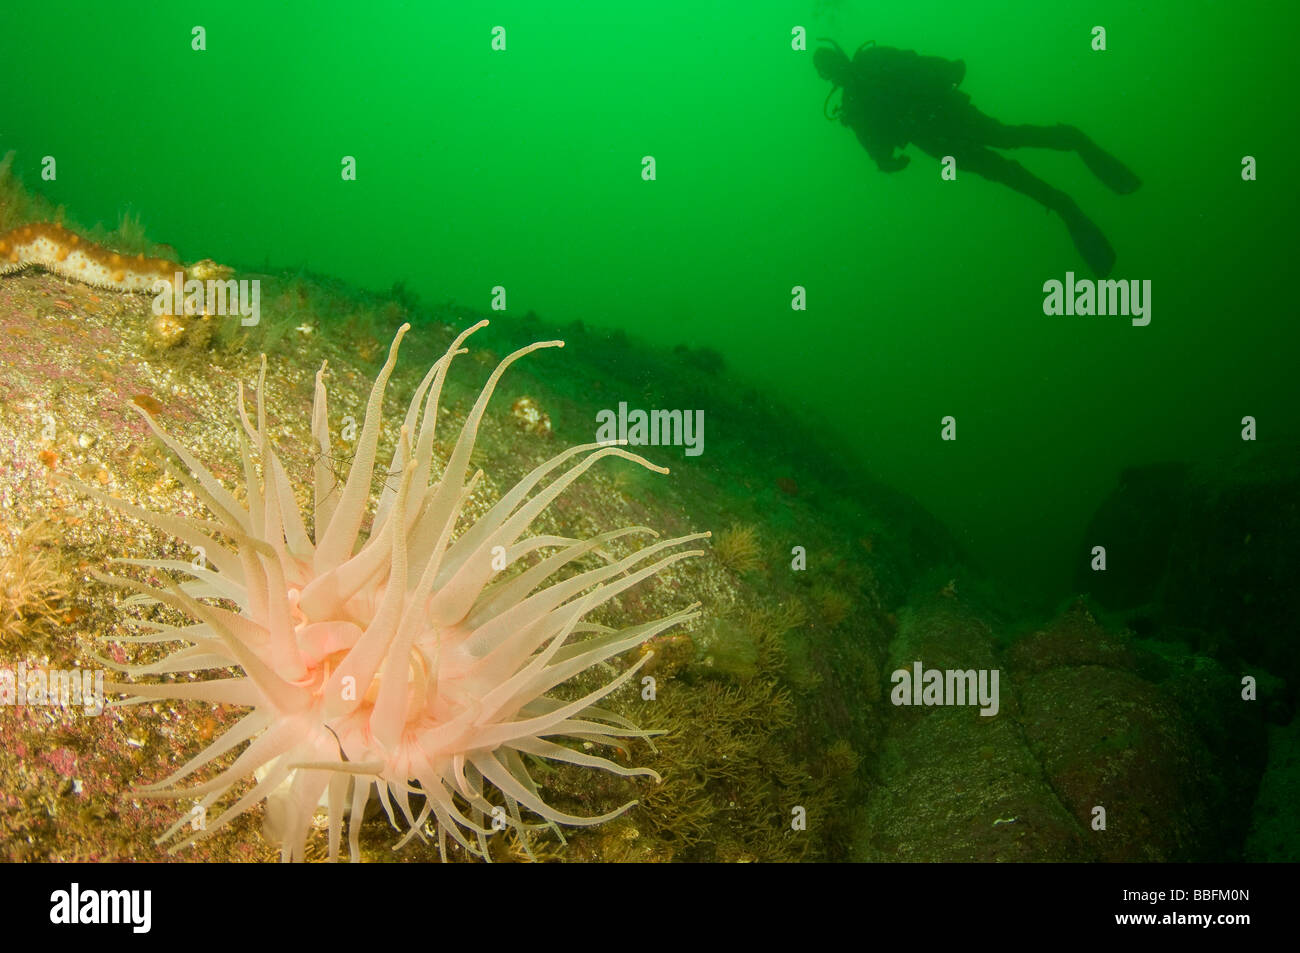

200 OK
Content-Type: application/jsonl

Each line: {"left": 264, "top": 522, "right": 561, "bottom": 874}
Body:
{"left": 0, "top": 159, "right": 1279, "bottom": 862}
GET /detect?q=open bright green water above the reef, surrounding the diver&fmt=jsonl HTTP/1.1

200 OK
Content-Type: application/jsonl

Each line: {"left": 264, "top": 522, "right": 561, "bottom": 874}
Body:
{"left": 0, "top": 0, "right": 1300, "bottom": 595}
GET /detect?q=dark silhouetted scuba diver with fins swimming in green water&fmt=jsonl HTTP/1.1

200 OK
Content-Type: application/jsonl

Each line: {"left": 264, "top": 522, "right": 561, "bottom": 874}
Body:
{"left": 813, "top": 40, "right": 1141, "bottom": 278}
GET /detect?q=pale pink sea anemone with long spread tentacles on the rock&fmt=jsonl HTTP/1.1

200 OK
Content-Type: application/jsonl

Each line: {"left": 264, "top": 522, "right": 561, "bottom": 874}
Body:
{"left": 87, "top": 321, "right": 709, "bottom": 861}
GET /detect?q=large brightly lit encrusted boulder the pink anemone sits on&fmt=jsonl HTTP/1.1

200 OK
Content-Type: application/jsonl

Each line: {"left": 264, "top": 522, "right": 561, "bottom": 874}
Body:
{"left": 0, "top": 198, "right": 915, "bottom": 861}
